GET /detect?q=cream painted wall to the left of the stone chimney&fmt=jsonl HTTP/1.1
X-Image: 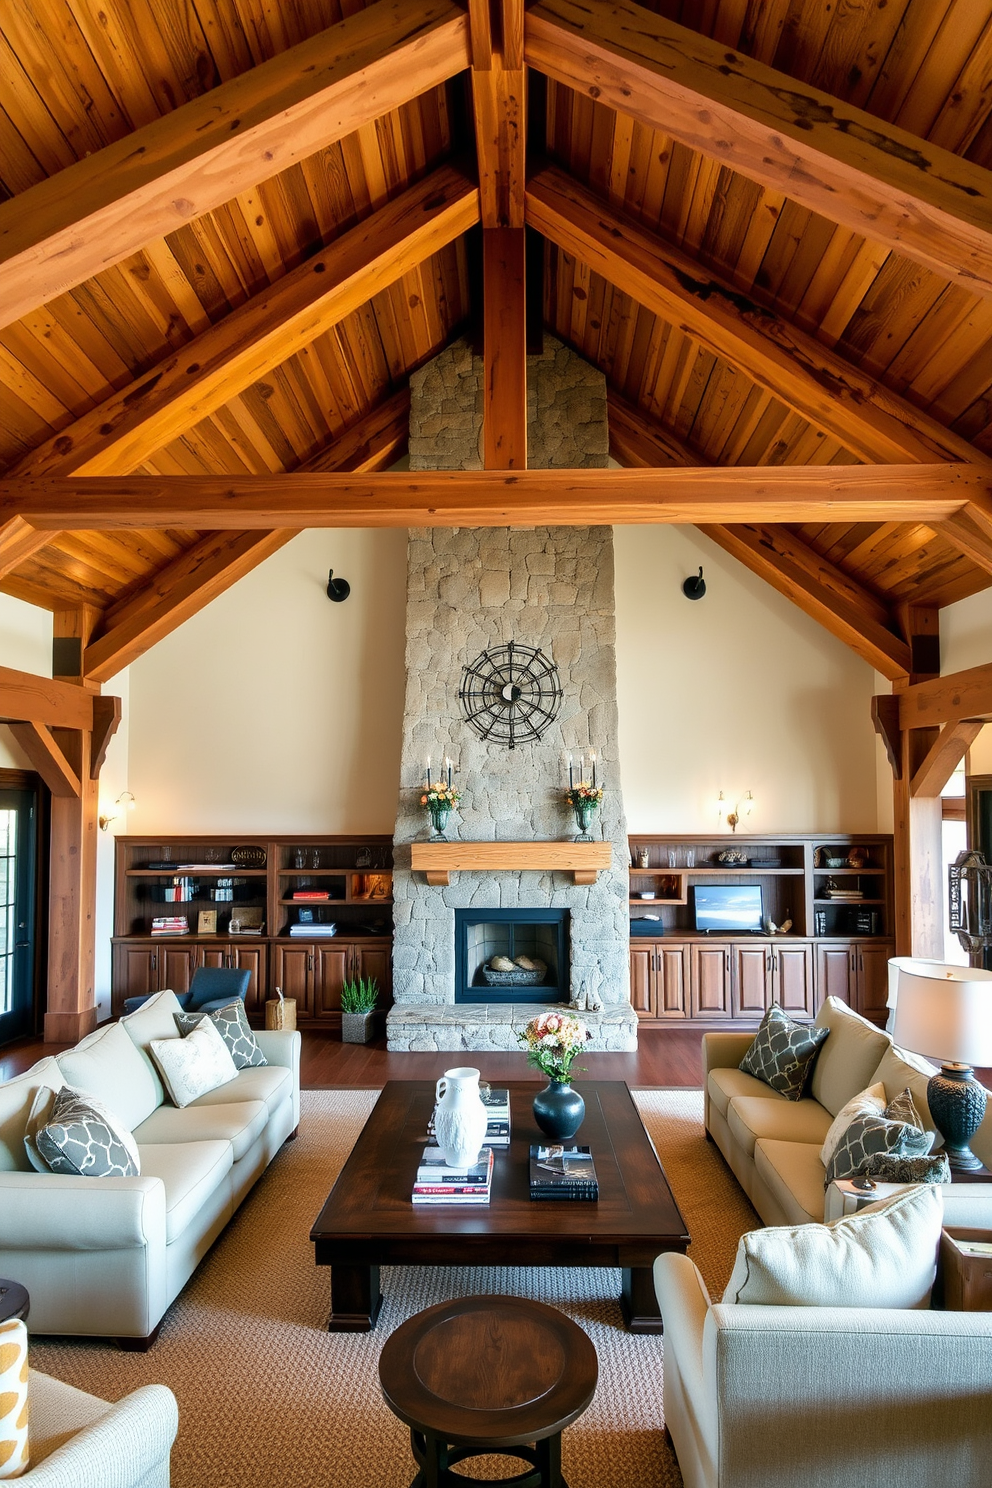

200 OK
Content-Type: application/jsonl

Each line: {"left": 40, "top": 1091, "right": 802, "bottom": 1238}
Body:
{"left": 128, "top": 530, "right": 406, "bottom": 833}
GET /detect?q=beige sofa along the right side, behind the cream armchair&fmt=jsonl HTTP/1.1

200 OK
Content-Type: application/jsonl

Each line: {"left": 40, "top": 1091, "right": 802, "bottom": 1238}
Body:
{"left": 702, "top": 997, "right": 992, "bottom": 1228}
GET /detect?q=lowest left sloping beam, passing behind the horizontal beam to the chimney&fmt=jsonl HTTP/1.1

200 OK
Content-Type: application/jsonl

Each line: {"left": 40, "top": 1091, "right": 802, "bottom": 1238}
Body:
{"left": 83, "top": 388, "right": 410, "bottom": 682}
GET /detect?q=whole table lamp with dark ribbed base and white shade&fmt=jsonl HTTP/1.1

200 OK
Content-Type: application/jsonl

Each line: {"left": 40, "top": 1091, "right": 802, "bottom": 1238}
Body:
{"left": 892, "top": 963, "right": 992, "bottom": 1171}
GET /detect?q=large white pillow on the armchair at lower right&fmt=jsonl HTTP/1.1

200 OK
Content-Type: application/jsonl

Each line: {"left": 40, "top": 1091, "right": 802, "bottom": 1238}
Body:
{"left": 723, "top": 1183, "right": 944, "bottom": 1308}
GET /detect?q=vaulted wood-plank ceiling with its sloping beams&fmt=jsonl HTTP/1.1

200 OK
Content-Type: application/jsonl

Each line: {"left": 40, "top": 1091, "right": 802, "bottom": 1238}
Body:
{"left": 0, "top": 0, "right": 992, "bottom": 682}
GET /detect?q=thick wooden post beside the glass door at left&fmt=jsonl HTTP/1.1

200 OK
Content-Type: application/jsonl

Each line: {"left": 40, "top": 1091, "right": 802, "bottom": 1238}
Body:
{"left": 45, "top": 607, "right": 100, "bottom": 1043}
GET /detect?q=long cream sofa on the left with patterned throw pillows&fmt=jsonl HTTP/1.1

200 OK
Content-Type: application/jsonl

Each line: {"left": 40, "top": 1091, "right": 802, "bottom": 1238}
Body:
{"left": 0, "top": 991, "right": 300, "bottom": 1348}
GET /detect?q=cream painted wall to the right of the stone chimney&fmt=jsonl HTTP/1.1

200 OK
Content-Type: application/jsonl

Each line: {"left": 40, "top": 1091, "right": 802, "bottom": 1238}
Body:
{"left": 614, "top": 527, "right": 876, "bottom": 832}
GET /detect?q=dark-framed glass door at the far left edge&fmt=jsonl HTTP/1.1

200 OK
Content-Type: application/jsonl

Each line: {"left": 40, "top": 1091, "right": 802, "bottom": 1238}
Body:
{"left": 0, "top": 786, "right": 37, "bottom": 1043}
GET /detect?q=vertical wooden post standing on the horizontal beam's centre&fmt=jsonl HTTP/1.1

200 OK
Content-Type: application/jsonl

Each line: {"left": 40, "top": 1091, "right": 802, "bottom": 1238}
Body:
{"left": 482, "top": 228, "right": 526, "bottom": 470}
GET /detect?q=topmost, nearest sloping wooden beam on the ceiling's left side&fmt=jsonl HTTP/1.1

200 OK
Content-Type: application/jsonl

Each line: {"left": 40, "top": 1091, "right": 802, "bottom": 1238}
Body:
{"left": 0, "top": 0, "right": 468, "bottom": 326}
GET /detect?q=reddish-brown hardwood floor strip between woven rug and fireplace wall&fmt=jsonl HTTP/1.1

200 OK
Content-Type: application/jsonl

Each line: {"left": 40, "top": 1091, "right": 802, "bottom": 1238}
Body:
{"left": 0, "top": 1028, "right": 702, "bottom": 1091}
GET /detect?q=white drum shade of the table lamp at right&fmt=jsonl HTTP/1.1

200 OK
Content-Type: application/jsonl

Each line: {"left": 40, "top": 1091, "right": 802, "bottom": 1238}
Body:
{"left": 892, "top": 963, "right": 992, "bottom": 1065}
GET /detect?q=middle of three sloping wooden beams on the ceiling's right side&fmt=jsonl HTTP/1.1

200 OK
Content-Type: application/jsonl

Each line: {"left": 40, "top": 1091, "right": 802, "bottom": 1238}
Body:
{"left": 526, "top": 165, "right": 985, "bottom": 464}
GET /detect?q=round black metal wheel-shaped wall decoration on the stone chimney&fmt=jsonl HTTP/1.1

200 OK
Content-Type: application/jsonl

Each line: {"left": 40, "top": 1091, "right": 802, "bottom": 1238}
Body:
{"left": 458, "top": 641, "right": 562, "bottom": 748}
